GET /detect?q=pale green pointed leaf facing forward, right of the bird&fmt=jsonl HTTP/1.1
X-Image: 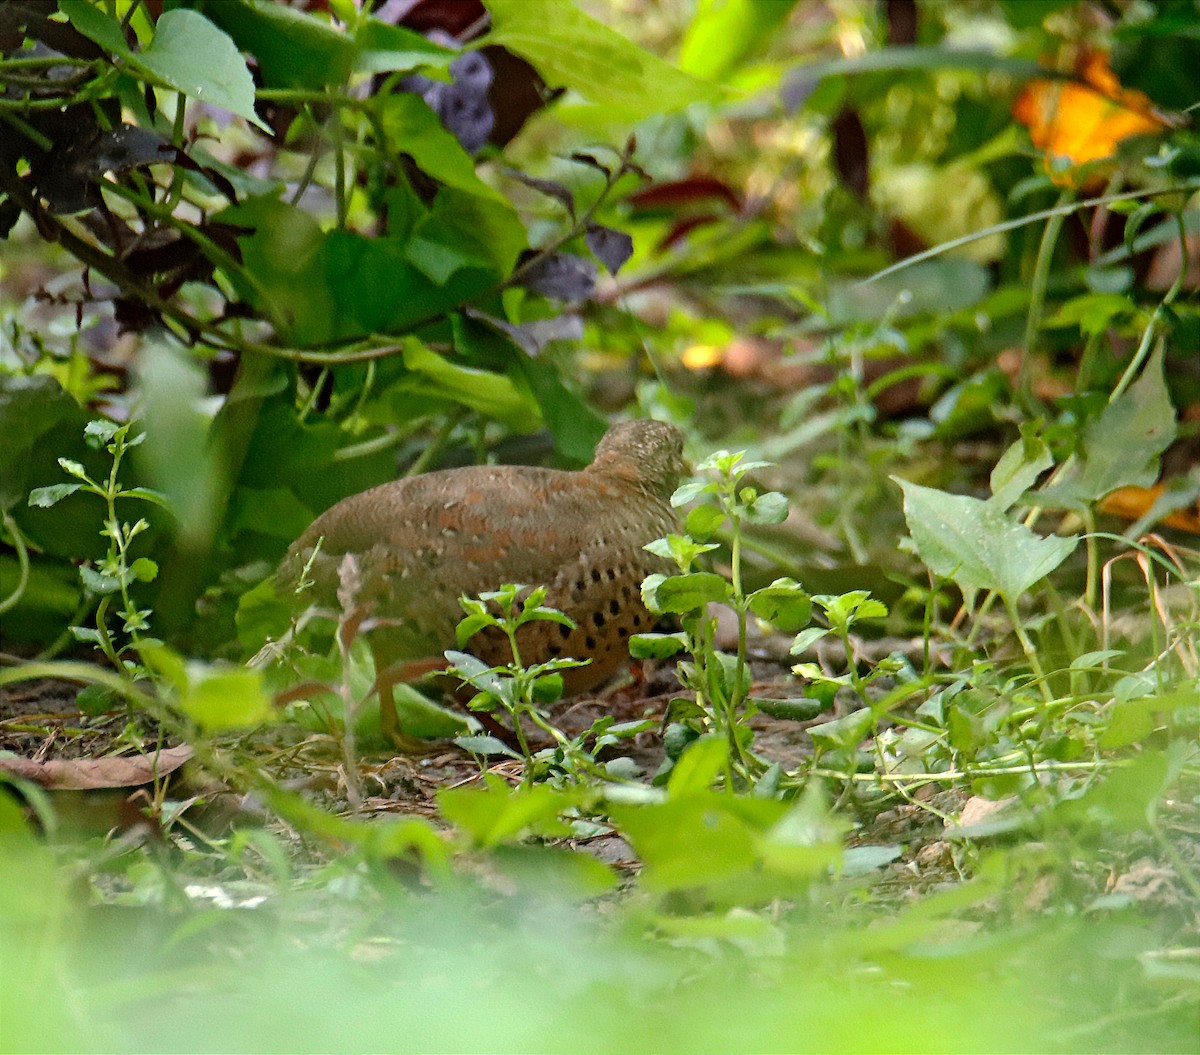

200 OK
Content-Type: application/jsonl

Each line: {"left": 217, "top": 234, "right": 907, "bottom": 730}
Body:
{"left": 893, "top": 478, "right": 1079, "bottom": 603}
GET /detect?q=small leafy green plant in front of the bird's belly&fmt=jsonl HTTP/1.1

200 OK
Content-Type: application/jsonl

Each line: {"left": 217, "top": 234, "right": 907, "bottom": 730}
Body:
{"left": 445, "top": 583, "right": 654, "bottom": 785}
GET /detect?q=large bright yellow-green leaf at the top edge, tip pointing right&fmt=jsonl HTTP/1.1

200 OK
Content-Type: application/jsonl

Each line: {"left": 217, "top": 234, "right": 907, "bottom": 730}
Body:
{"left": 485, "top": 0, "right": 725, "bottom": 119}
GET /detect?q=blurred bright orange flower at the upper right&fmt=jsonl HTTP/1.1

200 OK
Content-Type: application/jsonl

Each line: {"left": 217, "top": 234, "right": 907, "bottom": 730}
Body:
{"left": 1013, "top": 50, "right": 1170, "bottom": 182}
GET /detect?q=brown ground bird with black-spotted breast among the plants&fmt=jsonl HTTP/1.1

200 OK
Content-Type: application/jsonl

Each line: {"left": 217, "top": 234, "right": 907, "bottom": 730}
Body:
{"left": 278, "top": 421, "right": 684, "bottom": 738}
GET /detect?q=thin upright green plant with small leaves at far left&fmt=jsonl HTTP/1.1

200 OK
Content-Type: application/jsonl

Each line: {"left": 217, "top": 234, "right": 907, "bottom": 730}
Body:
{"left": 29, "top": 419, "right": 164, "bottom": 678}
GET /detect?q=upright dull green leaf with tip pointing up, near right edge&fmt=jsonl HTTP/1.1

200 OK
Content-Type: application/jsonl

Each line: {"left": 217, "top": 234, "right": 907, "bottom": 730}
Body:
{"left": 1037, "top": 344, "right": 1175, "bottom": 508}
